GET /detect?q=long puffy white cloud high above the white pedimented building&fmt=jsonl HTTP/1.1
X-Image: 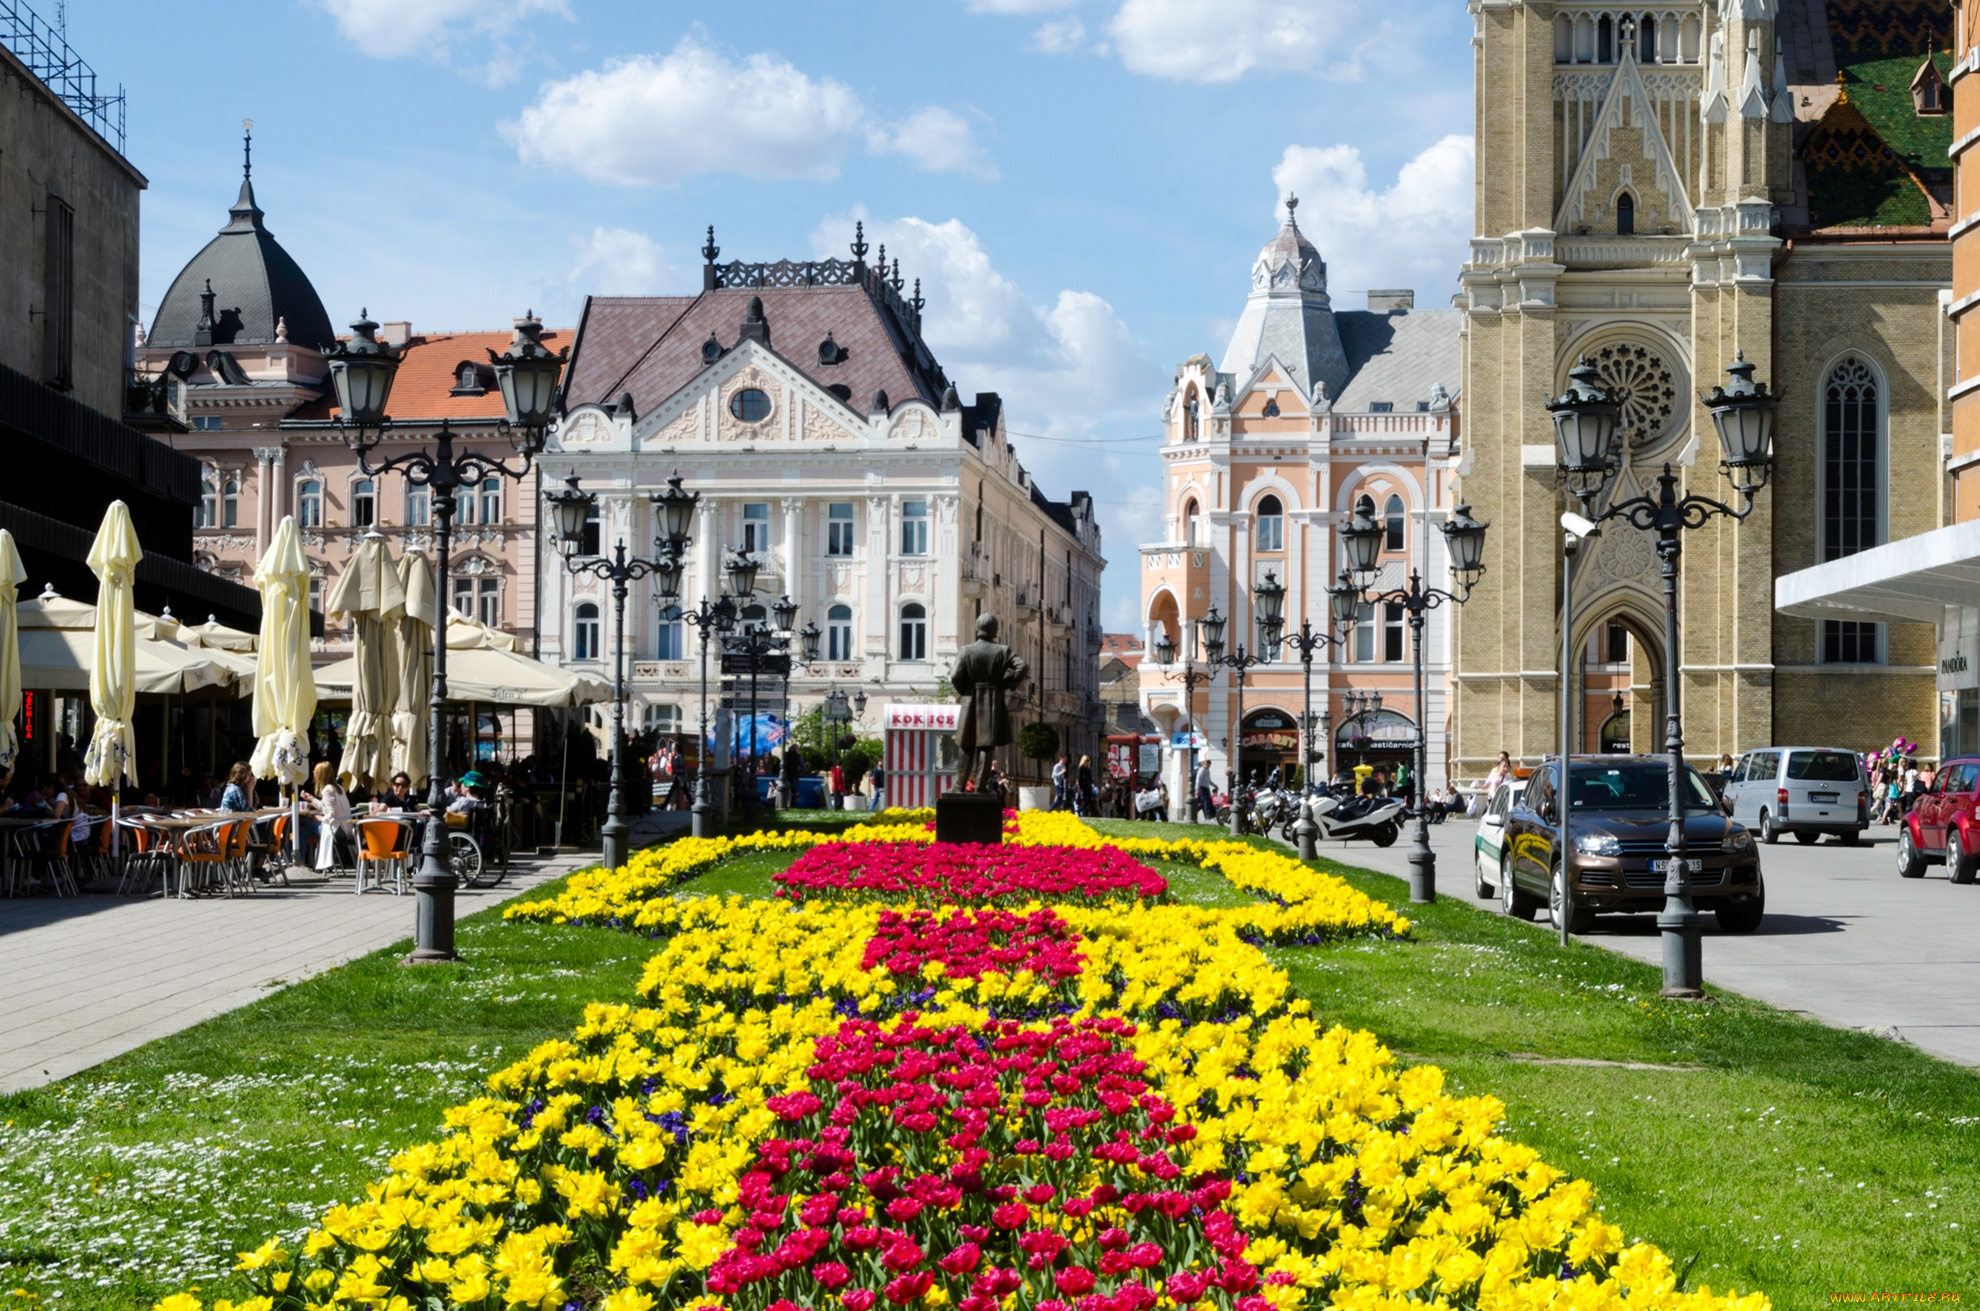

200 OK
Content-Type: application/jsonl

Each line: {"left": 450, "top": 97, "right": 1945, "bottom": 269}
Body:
{"left": 510, "top": 34, "right": 996, "bottom": 186}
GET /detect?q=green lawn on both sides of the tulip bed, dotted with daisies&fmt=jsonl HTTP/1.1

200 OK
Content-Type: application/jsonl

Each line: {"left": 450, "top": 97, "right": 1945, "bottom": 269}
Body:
{"left": 0, "top": 827, "right": 1980, "bottom": 1311}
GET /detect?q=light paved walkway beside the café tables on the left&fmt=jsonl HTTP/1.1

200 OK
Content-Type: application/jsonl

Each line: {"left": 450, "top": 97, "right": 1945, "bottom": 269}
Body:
{"left": 0, "top": 854, "right": 582, "bottom": 1093}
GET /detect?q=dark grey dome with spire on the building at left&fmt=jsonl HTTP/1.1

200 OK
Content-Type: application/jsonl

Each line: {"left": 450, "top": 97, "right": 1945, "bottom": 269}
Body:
{"left": 145, "top": 176, "right": 337, "bottom": 351}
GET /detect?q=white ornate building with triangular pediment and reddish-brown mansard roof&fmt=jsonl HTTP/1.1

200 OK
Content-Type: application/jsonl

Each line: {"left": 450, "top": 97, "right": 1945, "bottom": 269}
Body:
{"left": 539, "top": 232, "right": 1107, "bottom": 778}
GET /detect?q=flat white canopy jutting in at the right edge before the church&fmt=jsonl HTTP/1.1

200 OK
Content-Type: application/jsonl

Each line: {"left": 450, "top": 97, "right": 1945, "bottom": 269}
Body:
{"left": 1774, "top": 519, "right": 1980, "bottom": 624}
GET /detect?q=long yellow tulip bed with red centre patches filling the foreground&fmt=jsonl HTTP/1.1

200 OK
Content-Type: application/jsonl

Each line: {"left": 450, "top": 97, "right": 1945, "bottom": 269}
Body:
{"left": 182, "top": 822, "right": 1766, "bottom": 1311}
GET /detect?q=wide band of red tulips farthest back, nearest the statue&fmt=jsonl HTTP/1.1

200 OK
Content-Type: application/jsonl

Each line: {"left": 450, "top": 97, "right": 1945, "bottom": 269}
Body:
{"left": 776, "top": 842, "right": 1168, "bottom": 905}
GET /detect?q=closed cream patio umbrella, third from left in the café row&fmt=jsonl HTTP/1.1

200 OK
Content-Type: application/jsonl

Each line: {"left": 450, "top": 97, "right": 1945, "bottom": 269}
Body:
{"left": 249, "top": 515, "right": 317, "bottom": 786}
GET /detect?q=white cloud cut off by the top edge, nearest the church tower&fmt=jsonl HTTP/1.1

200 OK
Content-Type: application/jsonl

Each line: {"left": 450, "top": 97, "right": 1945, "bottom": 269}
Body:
{"left": 1109, "top": 0, "right": 1380, "bottom": 81}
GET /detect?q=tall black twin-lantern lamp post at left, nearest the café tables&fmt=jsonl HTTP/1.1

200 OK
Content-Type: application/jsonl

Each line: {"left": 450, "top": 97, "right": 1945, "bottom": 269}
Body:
{"left": 325, "top": 311, "right": 570, "bottom": 962}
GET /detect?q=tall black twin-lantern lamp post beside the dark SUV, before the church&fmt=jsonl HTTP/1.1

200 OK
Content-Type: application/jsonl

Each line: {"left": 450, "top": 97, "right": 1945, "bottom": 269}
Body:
{"left": 1546, "top": 353, "right": 1780, "bottom": 1000}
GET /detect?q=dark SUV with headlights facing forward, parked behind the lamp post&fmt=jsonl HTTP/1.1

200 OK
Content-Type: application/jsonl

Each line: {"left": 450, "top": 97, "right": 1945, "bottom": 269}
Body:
{"left": 1499, "top": 756, "right": 1766, "bottom": 933}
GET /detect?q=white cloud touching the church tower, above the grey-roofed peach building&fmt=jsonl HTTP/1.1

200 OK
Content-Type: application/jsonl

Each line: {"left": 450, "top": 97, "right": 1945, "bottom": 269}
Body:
{"left": 1271, "top": 135, "right": 1473, "bottom": 302}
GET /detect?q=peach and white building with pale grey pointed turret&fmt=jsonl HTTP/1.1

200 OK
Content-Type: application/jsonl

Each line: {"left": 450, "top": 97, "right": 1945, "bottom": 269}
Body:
{"left": 1139, "top": 200, "right": 1461, "bottom": 798}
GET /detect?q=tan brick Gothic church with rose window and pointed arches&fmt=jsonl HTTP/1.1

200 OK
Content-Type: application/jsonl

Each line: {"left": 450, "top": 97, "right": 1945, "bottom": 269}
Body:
{"left": 1453, "top": 0, "right": 1954, "bottom": 776}
